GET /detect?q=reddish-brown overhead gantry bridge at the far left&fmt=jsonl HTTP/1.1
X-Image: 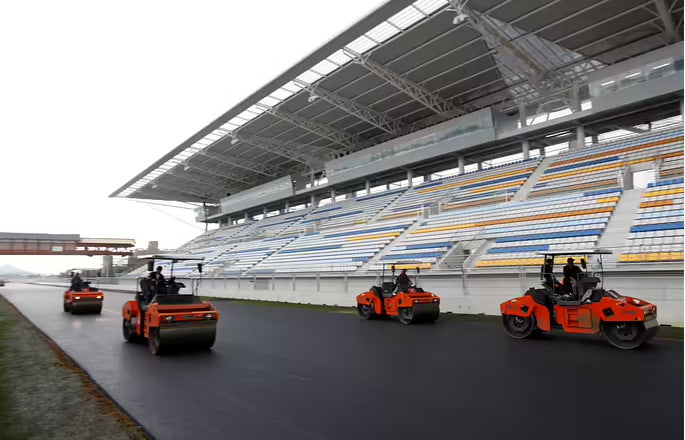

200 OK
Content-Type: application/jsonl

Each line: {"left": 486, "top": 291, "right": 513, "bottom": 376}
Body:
{"left": 0, "top": 232, "right": 136, "bottom": 256}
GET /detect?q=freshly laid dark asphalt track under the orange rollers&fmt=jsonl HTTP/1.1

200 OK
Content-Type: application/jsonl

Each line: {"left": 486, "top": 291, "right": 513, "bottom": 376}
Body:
{"left": 0, "top": 284, "right": 683, "bottom": 440}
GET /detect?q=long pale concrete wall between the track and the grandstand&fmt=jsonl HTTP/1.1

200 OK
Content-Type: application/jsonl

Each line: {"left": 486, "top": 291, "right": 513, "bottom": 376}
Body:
{"left": 34, "top": 272, "right": 684, "bottom": 326}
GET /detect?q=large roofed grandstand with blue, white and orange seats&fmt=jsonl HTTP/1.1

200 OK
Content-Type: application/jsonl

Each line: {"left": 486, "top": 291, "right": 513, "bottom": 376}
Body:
{"left": 112, "top": 0, "right": 683, "bottom": 322}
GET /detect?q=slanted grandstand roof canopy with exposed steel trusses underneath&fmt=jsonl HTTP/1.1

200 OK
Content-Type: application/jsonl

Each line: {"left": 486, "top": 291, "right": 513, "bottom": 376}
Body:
{"left": 111, "top": 0, "right": 683, "bottom": 202}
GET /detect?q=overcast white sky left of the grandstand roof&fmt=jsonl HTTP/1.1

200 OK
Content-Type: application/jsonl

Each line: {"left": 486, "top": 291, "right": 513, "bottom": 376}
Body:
{"left": 0, "top": 0, "right": 385, "bottom": 273}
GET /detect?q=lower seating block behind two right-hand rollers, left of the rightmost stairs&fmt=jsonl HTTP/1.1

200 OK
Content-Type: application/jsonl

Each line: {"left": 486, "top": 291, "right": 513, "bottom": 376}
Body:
{"left": 386, "top": 190, "right": 621, "bottom": 267}
